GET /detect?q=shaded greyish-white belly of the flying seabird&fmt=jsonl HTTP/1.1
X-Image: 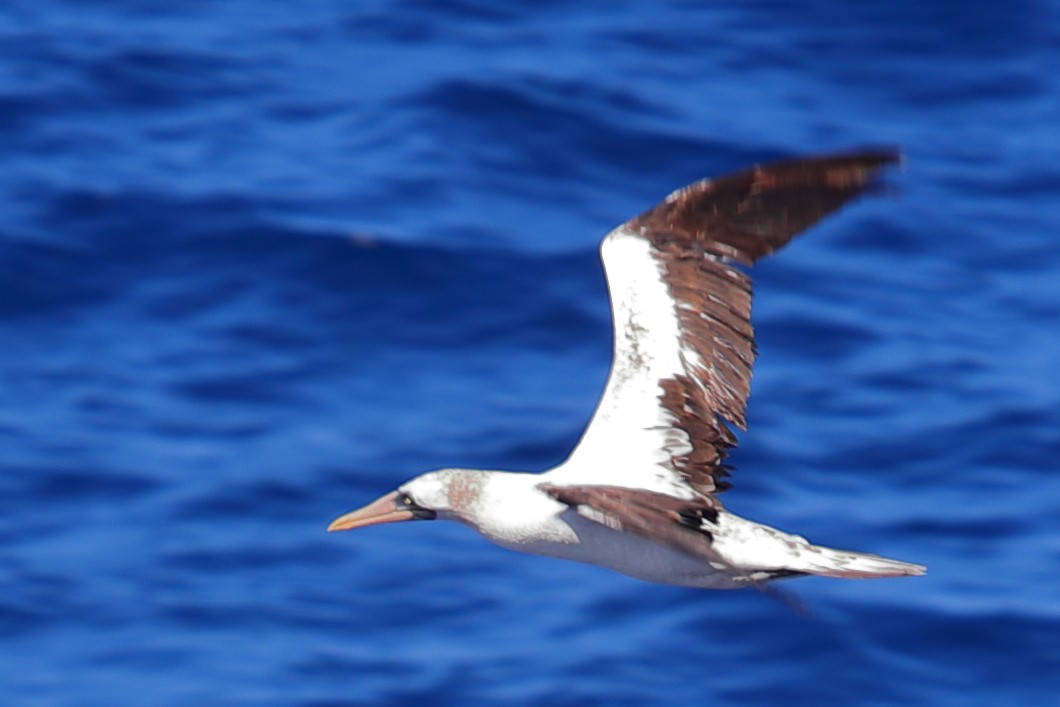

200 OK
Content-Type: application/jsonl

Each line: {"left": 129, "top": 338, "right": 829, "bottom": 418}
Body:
{"left": 494, "top": 513, "right": 746, "bottom": 589}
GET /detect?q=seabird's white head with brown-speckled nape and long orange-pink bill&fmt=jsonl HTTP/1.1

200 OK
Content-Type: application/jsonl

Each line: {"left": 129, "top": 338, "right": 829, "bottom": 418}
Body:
{"left": 328, "top": 469, "right": 482, "bottom": 531}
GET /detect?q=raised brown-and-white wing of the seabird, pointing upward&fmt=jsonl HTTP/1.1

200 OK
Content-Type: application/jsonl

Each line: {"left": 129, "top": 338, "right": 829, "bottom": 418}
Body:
{"left": 555, "top": 149, "right": 900, "bottom": 498}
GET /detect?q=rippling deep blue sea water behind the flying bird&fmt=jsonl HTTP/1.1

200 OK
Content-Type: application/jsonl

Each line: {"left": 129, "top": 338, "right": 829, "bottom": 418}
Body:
{"left": 0, "top": 0, "right": 1060, "bottom": 705}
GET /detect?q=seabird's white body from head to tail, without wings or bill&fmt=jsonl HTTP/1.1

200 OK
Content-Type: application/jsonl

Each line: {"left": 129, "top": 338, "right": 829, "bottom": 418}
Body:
{"left": 409, "top": 465, "right": 919, "bottom": 589}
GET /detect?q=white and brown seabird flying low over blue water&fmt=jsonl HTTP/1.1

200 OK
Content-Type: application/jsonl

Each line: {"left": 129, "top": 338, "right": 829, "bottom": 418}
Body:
{"left": 329, "top": 149, "right": 925, "bottom": 589}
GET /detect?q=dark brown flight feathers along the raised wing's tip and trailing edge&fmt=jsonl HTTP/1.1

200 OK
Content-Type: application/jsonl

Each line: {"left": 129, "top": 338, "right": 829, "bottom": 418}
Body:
{"left": 624, "top": 149, "right": 900, "bottom": 495}
